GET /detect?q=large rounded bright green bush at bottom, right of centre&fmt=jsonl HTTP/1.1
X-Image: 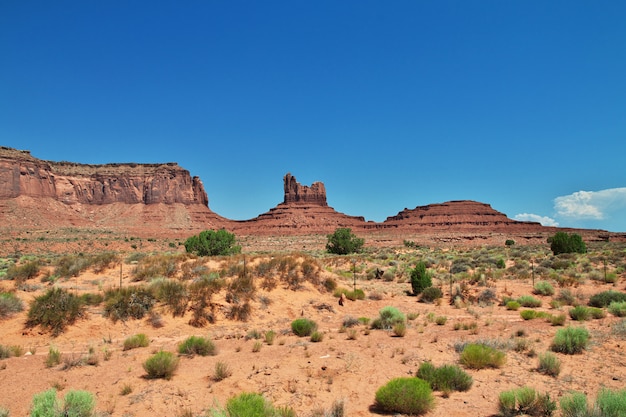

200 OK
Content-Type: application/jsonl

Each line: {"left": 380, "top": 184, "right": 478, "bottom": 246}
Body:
{"left": 375, "top": 377, "right": 435, "bottom": 415}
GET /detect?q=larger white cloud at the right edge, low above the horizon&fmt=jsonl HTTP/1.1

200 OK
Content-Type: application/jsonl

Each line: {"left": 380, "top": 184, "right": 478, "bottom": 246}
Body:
{"left": 554, "top": 187, "right": 626, "bottom": 220}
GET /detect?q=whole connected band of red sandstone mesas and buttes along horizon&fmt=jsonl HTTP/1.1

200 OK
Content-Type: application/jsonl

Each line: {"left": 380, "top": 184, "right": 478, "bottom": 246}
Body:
{"left": 0, "top": 147, "right": 626, "bottom": 250}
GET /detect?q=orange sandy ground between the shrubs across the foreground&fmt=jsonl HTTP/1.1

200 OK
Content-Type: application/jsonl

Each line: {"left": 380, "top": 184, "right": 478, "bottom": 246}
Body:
{"left": 0, "top": 256, "right": 626, "bottom": 417}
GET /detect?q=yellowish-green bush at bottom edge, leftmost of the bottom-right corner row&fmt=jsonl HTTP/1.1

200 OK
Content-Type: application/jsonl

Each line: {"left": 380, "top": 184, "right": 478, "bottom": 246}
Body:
{"left": 498, "top": 386, "right": 556, "bottom": 417}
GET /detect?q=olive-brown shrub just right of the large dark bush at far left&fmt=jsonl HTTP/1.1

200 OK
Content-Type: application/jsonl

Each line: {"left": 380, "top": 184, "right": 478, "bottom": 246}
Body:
{"left": 104, "top": 286, "right": 156, "bottom": 323}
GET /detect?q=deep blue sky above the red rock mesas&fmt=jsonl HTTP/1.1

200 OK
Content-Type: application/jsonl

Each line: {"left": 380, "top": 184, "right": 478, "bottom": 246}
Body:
{"left": 0, "top": 0, "right": 626, "bottom": 231}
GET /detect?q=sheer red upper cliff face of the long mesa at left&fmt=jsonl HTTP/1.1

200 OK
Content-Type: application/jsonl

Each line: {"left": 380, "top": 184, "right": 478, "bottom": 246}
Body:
{"left": 0, "top": 147, "right": 209, "bottom": 207}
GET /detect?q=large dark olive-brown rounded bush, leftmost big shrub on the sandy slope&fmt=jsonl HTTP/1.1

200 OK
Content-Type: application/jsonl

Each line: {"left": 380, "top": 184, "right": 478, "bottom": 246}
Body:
{"left": 26, "top": 288, "right": 85, "bottom": 336}
